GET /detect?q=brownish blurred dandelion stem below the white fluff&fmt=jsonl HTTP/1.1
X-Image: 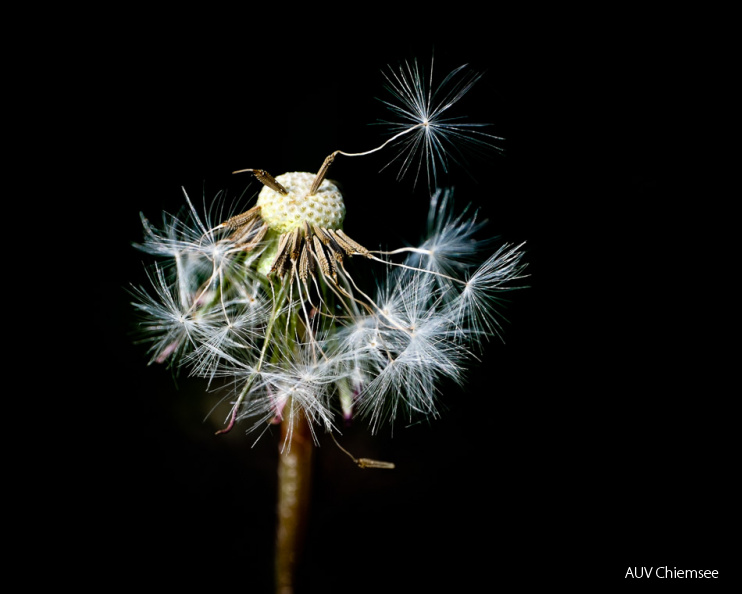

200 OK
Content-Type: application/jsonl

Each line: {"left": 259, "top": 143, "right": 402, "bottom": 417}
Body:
{"left": 274, "top": 402, "right": 314, "bottom": 594}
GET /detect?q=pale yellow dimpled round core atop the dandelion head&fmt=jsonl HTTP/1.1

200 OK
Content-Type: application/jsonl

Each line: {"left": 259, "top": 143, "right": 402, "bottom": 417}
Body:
{"left": 258, "top": 171, "right": 345, "bottom": 233}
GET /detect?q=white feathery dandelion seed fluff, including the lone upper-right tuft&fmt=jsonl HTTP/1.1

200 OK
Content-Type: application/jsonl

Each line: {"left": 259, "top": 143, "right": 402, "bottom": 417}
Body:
{"left": 133, "top": 57, "right": 525, "bottom": 442}
